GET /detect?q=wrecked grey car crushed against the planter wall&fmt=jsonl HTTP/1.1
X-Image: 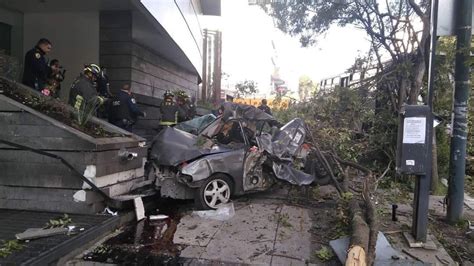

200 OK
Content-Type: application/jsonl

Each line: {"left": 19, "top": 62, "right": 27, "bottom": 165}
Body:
{"left": 149, "top": 104, "right": 329, "bottom": 209}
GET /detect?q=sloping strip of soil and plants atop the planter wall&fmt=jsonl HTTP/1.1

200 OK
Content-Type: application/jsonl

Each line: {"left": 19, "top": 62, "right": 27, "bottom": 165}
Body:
{"left": 0, "top": 79, "right": 119, "bottom": 138}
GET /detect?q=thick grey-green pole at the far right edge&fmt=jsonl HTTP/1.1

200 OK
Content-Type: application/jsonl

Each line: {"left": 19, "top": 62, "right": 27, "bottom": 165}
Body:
{"left": 446, "top": 0, "right": 472, "bottom": 223}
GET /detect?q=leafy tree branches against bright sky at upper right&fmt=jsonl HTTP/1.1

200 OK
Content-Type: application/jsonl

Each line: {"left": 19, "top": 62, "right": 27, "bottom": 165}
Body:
{"left": 263, "top": 0, "right": 430, "bottom": 110}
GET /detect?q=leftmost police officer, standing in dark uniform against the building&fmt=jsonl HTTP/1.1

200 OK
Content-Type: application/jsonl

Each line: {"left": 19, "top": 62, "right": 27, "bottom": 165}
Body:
{"left": 22, "top": 38, "right": 52, "bottom": 91}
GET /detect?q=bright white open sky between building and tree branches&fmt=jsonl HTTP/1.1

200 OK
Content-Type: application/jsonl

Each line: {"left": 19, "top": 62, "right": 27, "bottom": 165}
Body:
{"left": 202, "top": 0, "right": 369, "bottom": 96}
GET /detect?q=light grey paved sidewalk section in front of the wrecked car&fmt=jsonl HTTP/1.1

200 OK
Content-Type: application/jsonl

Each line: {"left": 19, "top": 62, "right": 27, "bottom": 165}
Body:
{"left": 174, "top": 199, "right": 312, "bottom": 265}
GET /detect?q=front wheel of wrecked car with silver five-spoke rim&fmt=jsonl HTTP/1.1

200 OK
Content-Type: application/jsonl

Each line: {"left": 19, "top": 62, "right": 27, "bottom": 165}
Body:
{"left": 195, "top": 174, "right": 233, "bottom": 209}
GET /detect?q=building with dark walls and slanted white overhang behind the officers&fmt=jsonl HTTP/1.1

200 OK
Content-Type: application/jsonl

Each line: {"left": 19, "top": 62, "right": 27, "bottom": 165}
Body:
{"left": 0, "top": 0, "right": 221, "bottom": 138}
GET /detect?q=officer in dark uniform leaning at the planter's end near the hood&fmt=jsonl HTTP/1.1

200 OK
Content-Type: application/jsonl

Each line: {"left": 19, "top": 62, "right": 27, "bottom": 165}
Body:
{"left": 109, "top": 84, "right": 146, "bottom": 132}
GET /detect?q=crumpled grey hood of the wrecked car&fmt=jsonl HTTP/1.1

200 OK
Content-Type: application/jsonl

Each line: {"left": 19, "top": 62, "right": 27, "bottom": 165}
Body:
{"left": 150, "top": 127, "right": 231, "bottom": 166}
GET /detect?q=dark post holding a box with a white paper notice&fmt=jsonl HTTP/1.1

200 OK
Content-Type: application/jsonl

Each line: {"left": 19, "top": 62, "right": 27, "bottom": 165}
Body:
{"left": 397, "top": 0, "right": 438, "bottom": 242}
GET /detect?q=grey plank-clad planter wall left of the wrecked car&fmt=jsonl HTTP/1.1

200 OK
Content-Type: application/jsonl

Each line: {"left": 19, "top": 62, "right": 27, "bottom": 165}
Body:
{"left": 0, "top": 80, "right": 147, "bottom": 213}
